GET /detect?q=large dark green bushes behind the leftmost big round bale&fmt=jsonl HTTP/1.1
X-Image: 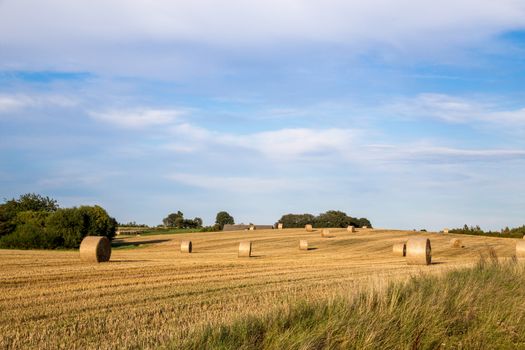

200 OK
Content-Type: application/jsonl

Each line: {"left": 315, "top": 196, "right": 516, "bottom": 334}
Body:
{"left": 0, "top": 194, "right": 117, "bottom": 249}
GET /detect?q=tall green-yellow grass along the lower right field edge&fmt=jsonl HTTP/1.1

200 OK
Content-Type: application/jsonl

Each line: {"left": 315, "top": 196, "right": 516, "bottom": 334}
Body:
{"left": 175, "top": 256, "right": 525, "bottom": 349}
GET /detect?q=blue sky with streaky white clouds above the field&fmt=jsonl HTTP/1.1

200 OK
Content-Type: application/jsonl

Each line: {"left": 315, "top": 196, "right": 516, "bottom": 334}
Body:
{"left": 0, "top": 0, "right": 525, "bottom": 230}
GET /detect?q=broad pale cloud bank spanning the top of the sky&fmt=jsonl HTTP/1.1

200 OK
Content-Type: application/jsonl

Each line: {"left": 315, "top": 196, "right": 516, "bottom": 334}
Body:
{"left": 0, "top": 0, "right": 525, "bottom": 75}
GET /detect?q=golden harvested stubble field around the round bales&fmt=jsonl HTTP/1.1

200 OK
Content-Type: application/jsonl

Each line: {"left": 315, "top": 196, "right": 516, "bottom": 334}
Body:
{"left": 0, "top": 229, "right": 516, "bottom": 349}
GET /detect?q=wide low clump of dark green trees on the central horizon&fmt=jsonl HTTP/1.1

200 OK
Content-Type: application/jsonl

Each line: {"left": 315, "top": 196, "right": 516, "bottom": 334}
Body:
{"left": 278, "top": 210, "right": 372, "bottom": 228}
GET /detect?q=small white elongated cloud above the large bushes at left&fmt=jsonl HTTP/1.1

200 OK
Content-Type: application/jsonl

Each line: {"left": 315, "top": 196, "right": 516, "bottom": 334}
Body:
{"left": 89, "top": 109, "right": 185, "bottom": 128}
